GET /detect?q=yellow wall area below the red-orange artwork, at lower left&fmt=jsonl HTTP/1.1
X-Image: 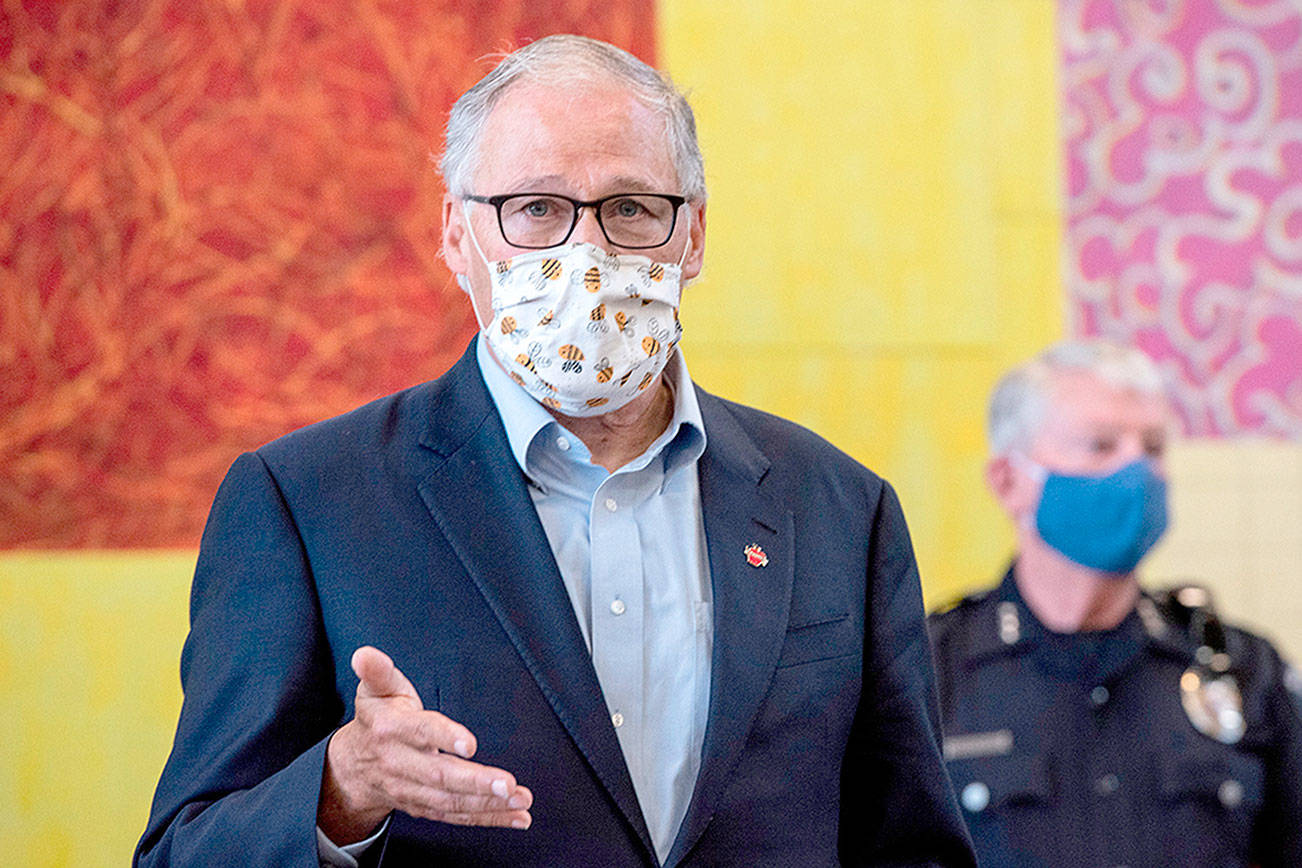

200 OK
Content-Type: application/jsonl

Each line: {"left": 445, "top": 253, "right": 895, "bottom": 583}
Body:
{"left": 0, "top": 552, "right": 195, "bottom": 868}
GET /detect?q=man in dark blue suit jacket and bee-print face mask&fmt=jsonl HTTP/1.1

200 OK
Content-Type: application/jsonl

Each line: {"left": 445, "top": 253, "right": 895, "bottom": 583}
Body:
{"left": 137, "top": 36, "right": 971, "bottom": 865}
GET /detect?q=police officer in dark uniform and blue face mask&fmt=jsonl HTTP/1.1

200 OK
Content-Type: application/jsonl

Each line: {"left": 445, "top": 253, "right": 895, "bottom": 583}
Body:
{"left": 930, "top": 342, "right": 1302, "bottom": 868}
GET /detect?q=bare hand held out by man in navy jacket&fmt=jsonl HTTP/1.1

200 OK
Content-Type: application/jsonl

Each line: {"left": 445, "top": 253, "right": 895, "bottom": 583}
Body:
{"left": 316, "top": 645, "right": 534, "bottom": 845}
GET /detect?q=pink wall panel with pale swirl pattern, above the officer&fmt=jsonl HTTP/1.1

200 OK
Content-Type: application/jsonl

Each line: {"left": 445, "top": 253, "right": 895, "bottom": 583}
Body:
{"left": 1059, "top": 0, "right": 1302, "bottom": 440}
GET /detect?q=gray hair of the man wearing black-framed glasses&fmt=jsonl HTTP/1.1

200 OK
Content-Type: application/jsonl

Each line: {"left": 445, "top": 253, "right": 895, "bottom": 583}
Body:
{"left": 440, "top": 34, "right": 706, "bottom": 202}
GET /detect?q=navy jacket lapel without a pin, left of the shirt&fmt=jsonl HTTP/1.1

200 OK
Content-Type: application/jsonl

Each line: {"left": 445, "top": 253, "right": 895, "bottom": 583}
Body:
{"left": 419, "top": 344, "right": 654, "bottom": 852}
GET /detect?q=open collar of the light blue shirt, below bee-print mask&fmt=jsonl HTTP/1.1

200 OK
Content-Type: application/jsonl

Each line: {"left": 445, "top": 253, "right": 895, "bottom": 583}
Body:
{"left": 475, "top": 336, "right": 706, "bottom": 484}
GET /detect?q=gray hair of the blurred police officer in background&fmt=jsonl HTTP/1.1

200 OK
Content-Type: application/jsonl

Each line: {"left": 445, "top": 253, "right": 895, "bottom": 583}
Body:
{"left": 986, "top": 340, "right": 1165, "bottom": 455}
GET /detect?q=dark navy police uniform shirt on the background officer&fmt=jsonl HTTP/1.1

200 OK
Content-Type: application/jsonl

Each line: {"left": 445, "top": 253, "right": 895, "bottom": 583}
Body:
{"left": 928, "top": 570, "right": 1302, "bottom": 868}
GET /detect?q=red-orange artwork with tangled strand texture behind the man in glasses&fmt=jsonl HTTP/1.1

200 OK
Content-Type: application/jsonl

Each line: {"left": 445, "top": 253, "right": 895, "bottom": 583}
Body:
{"left": 0, "top": 0, "right": 655, "bottom": 548}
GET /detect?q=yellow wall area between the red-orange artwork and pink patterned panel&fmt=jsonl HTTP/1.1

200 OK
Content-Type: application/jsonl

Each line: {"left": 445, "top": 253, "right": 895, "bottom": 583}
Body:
{"left": 659, "top": 0, "right": 1062, "bottom": 605}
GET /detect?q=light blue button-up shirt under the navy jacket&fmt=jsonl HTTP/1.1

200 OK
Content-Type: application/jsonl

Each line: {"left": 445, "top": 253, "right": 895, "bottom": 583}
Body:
{"left": 477, "top": 340, "right": 713, "bottom": 861}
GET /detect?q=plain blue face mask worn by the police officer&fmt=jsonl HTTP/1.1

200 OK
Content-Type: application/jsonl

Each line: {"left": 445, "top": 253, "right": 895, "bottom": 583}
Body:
{"left": 1019, "top": 457, "right": 1167, "bottom": 576}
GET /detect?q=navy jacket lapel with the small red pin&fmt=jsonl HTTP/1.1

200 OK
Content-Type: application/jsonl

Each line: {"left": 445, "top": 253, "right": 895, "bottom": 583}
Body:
{"left": 665, "top": 389, "right": 796, "bottom": 865}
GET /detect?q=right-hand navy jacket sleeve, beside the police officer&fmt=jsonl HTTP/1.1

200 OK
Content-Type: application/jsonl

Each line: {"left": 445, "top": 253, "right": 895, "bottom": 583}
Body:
{"left": 840, "top": 483, "right": 977, "bottom": 867}
